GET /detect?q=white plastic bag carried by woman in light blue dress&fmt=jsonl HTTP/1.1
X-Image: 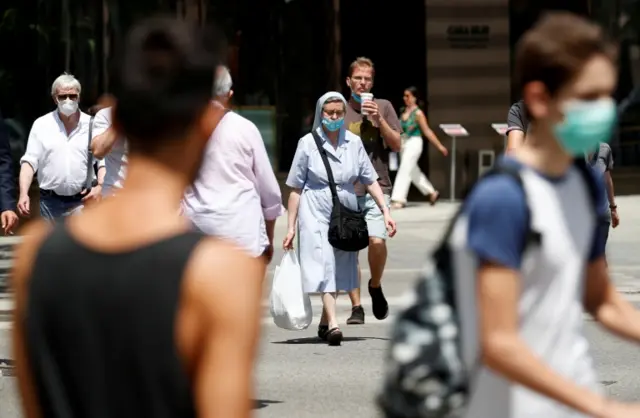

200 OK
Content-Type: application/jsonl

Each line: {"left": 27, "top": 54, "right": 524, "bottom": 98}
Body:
{"left": 270, "top": 251, "right": 313, "bottom": 331}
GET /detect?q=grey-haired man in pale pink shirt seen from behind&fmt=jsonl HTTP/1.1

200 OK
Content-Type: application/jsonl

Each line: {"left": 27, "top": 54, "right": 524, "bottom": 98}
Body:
{"left": 182, "top": 67, "right": 283, "bottom": 262}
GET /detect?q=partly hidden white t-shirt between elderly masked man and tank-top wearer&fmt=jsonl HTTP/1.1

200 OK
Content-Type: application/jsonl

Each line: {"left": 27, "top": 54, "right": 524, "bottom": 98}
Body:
{"left": 93, "top": 107, "right": 128, "bottom": 196}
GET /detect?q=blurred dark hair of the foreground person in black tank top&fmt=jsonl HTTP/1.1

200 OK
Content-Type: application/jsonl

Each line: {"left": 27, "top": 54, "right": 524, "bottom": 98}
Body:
{"left": 113, "top": 17, "right": 221, "bottom": 151}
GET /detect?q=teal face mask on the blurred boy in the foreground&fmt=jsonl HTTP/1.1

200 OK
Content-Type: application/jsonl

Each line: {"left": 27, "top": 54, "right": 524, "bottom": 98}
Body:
{"left": 553, "top": 98, "right": 617, "bottom": 156}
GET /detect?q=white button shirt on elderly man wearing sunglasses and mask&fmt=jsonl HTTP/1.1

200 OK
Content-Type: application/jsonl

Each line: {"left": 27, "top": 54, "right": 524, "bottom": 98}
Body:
{"left": 20, "top": 110, "right": 104, "bottom": 196}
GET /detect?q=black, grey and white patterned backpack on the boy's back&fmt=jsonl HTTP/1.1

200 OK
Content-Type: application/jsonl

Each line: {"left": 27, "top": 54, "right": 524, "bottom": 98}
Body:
{"left": 377, "top": 159, "right": 597, "bottom": 418}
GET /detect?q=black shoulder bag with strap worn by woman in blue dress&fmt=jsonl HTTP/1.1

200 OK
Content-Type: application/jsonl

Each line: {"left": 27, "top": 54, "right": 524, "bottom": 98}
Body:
{"left": 311, "top": 131, "right": 369, "bottom": 252}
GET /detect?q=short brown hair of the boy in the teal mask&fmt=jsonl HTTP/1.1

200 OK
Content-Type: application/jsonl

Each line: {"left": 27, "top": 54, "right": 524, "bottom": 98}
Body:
{"left": 515, "top": 12, "right": 616, "bottom": 95}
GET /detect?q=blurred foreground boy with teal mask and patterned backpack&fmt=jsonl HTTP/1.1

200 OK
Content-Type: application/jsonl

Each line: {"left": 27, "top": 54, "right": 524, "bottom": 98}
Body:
{"left": 380, "top": 13, "right": 640, "bottom": 418}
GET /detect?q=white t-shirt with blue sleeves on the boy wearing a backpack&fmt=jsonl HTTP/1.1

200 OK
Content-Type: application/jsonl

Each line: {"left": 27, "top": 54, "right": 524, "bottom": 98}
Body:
{"left": 451, "top": 160, "right": 604, "bottom": 418}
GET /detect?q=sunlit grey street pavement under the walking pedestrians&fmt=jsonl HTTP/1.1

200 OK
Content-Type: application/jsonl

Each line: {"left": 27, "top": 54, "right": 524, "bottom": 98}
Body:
{"left": 0, "top": 196, "right": 640, "bottom": 418}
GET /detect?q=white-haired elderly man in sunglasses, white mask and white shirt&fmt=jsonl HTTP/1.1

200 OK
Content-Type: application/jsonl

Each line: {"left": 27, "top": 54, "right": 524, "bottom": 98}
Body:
{"left": 18, "top": 73, "right": 105, "bottom": 221}
